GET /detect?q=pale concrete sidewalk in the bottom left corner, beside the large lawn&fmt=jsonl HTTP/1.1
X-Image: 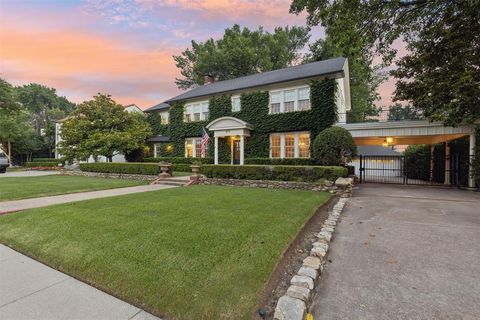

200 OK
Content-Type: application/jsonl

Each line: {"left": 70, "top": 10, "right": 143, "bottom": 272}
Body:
{"left": 0, "top": 244, "right": 159, "bottom": 320}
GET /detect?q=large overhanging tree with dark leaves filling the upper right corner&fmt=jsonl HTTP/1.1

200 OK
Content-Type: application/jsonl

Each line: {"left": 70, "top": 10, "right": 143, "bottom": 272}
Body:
{"left": 290, "top": 0, "right": 480, "bottom": 125}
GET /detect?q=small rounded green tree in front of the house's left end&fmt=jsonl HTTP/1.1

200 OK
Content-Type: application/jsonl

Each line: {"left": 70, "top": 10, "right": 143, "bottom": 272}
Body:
{"left": 59, "top": 94, "right": 152, "bottom": 162}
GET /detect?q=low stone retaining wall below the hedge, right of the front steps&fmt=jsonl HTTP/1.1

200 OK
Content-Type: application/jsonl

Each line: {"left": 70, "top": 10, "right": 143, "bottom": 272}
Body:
{"left": 198, "top": 177, "right": 348, "bottom": 194}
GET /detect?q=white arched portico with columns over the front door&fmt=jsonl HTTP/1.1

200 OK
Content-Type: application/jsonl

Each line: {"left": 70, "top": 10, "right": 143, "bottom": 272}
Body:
{"left": 207, "top": 117, "right": 252, "bottom": 165}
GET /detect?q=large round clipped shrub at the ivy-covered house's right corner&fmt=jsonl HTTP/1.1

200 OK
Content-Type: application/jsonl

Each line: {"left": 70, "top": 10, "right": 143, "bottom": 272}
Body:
{"left": 313, "top": 127, "right": 357, "bottom": 166}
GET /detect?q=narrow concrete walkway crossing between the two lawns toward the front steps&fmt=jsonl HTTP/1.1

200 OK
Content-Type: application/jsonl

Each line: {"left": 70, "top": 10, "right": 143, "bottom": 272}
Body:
{"left": 0, "top": 184, "right": 176, "bottom": 214}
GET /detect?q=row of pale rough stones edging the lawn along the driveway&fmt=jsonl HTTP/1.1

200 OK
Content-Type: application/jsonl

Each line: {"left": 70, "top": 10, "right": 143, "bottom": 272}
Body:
{"left": 273, "top": 196, "right": 352, "bottom": 320}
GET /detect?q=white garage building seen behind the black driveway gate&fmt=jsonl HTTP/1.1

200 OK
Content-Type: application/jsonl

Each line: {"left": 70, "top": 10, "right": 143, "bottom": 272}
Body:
{"left": 349, "top": 146, "right": 403, "bottom": 177}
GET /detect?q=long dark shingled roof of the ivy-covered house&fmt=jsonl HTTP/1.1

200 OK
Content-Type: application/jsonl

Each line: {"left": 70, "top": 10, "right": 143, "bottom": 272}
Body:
{"left": 163, "top": 57, "right": 346, "bottom": 103}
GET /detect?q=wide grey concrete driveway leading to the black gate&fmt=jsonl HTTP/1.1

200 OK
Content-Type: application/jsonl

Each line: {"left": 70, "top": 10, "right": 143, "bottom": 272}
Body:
{"left": 311, "top": 184, "right": 480, "bottom": 320}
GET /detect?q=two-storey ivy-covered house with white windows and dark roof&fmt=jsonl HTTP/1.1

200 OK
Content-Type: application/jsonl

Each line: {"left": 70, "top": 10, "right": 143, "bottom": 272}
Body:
{"left": 145, "top": 58, "right": 350, "bottom": 164}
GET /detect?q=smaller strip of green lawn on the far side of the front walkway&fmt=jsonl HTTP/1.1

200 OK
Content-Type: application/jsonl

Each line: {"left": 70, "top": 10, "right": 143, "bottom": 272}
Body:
{"left": 0, "top": 175, "right": 147, "bottom": 201}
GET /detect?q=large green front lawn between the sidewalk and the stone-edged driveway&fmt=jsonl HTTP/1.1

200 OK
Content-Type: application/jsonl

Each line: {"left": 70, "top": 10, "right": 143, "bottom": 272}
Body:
{"left": 0, "top": 186, "right": 330, "bottom": 320}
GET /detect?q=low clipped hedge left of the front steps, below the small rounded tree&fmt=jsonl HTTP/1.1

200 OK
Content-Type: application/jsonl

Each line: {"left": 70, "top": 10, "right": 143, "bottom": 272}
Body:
{"left": 80, "top": 162, "right": 160, "bottom": 175}
